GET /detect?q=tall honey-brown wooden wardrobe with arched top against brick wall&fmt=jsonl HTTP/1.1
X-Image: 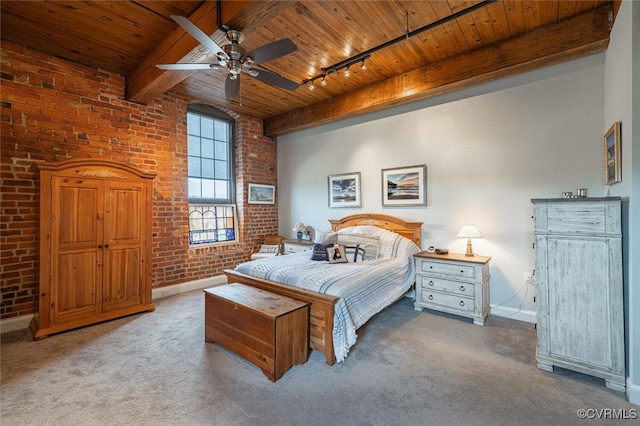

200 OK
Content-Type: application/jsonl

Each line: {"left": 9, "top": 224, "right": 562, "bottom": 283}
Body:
{"left": 30, "top": 159, "right": 155, "bottom": 340}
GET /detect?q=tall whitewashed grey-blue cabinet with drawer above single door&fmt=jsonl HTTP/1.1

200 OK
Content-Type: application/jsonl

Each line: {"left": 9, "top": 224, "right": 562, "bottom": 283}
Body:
{"left": 531, "top": 197, "right": 626, "bottom": 392}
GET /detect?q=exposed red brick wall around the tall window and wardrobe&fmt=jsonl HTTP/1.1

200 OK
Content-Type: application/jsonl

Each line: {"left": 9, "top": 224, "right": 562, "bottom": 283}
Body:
{"left": 0, "top": 40, "right": 278, "bottom": 318}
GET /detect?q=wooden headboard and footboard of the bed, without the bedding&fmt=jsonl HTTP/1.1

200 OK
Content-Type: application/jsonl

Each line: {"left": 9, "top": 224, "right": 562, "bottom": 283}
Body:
{"left": 224, "top": 213, "right": 422, "bottom": 365}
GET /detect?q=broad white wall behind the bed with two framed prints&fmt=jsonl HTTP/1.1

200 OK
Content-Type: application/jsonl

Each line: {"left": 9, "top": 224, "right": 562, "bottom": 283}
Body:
{"left": 278, "top": 54, "right": 604, "bottom": 322}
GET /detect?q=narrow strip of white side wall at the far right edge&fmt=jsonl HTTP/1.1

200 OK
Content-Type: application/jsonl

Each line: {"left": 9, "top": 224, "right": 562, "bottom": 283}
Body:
{"left": 603, "top": 1, "right": 640, "bottom": 405}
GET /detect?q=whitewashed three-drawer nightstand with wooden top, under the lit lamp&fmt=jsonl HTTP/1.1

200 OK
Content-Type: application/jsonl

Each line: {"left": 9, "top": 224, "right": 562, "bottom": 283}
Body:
{"left": 414, "top": 251, "right": 491, "bottom": 325}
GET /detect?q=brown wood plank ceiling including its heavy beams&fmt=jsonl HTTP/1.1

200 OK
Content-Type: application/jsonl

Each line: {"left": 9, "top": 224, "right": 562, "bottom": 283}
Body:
{"left": 0, "top": 0, "right": 619, "bottom": 136}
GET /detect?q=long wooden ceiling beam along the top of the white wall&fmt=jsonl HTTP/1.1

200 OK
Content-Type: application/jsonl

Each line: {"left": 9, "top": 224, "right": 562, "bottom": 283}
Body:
{"left": 264, "top": 3, "right": 612, "bottom": 137}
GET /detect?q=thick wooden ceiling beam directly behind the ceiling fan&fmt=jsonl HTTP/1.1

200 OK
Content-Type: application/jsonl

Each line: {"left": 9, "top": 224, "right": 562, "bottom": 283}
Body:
{"left": 126, "top": 0, "right": 291, "bottom": 104}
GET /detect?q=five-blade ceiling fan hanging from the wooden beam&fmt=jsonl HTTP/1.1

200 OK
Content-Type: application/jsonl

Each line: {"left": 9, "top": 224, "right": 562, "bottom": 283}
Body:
{"left": 156, "top": 15, "right": 298, "bottom": 99}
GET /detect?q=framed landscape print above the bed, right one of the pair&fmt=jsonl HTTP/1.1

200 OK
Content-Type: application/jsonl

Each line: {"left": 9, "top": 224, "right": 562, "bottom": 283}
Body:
{"left": 382, "top": 165, "right": 427, "bottom": 207}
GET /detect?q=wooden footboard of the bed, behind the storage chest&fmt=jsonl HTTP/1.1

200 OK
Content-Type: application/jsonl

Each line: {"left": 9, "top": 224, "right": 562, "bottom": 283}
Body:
{"left": 224, "top": 269, "right": 338, "bottom": 365}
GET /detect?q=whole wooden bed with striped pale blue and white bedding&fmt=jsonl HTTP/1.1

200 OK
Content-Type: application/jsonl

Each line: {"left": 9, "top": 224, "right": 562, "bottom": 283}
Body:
{"left": 224, "top": 213, "right": 422, "bottom": 365}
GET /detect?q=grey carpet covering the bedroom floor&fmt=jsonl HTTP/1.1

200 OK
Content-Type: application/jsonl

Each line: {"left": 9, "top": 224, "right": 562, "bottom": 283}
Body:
{"left": 0, "top": 291, "right": 638, "bottom": 426}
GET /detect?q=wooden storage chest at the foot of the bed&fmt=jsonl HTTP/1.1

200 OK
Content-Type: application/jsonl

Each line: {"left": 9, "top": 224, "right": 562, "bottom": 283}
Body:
{"left": 204, "top": 283, "right": 309, "bottom": 382}
